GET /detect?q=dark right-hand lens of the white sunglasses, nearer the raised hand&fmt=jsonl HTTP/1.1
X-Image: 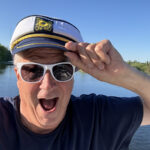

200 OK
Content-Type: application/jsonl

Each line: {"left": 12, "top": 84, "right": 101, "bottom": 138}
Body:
{"left": 53, "top": 64, "right": 73, "bottom": 81}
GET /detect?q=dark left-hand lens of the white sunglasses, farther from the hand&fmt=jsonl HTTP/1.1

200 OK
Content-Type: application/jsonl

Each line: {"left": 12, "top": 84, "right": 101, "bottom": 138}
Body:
{"left": 21, "top": 64, "right": 44, "bottom": 82}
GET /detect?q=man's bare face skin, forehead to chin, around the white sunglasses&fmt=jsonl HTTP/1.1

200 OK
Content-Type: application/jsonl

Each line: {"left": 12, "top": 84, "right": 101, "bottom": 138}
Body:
{"left": 15, "top": 48, "right": 73, "bottom": 134}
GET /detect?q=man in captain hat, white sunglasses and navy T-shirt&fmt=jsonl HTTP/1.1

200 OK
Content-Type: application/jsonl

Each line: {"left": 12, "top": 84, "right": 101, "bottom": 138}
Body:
{"left": 0, "top": 15, "right": 150, "bottom": 150}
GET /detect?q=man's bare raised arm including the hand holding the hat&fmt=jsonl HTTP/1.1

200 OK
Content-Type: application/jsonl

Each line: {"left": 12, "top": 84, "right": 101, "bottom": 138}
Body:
{"left": 65, "top": 40, "right": 150, "bottom": 125}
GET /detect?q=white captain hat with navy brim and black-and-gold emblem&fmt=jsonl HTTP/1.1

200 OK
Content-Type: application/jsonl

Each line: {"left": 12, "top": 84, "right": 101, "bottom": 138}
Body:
{"left": 10, "top": 15, "right": 83, "bottom": 55}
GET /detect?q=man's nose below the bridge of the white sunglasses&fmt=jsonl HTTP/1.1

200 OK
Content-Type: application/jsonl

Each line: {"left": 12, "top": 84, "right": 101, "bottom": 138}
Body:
{"left": 40, "top": 70, "right": 57, "bottom": 89}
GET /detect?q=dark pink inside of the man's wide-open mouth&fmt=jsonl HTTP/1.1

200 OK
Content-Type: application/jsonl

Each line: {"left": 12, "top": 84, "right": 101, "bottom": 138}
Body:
{"left": 40, "top": 99, "right": 56, "bottom": 111}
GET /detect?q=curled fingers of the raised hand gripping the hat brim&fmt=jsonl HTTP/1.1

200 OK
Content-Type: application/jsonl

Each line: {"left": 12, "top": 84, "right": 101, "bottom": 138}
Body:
{"left": 65, "top": 40, "right": 112, "bottom": 70}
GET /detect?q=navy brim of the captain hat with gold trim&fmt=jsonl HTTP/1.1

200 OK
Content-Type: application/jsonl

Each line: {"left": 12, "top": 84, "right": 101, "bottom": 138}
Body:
{"left": 12, "top": 37, "right": 68, "bottom": 55}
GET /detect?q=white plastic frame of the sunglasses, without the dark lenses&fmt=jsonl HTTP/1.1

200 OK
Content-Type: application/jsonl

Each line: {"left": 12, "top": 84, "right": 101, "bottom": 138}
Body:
{"left": 16, "top": 62, "right": 76, "bottom": 83}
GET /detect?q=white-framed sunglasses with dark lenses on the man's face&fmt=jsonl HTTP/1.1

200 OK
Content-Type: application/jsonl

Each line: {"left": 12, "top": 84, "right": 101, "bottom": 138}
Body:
{"left": 16, "top": 62, "right": 75, "bottom": 83}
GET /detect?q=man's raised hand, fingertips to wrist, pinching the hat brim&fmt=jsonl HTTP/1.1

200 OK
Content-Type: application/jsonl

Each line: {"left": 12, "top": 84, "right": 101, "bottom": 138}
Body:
{"left": 65, "top": 40, "right": 127, "bottom": 85}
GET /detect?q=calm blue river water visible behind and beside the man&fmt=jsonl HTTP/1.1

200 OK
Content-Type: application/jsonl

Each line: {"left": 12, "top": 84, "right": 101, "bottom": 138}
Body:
{"left": 0, "top": 65, "right": 150, "bottom": 150}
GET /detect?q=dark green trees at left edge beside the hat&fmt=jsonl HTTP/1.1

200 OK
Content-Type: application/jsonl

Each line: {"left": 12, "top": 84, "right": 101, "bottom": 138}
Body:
{"left": 0, "top": 44, "right": 12, "bottom": 62}
